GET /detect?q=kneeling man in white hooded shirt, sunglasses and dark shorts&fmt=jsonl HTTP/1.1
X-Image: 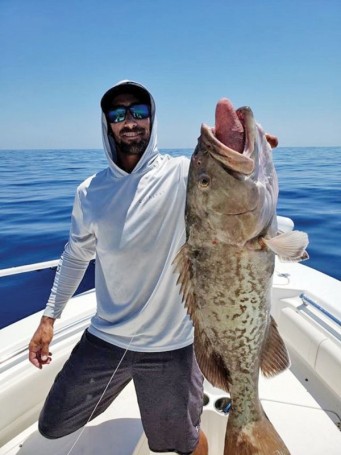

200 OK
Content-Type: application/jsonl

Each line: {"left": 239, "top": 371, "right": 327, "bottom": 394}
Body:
{"left": 29, "top": 81, "right": 207, "bottom": 455}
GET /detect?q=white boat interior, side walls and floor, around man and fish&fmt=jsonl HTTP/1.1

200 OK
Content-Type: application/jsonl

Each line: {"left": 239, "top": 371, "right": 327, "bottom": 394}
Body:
{"left": 0, "top": 253, "right": 341, "bottom": 455}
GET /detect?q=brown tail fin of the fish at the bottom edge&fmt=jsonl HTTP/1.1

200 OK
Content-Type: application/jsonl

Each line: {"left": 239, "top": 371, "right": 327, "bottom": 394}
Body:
{"left": 224, "top": 413, "right": 290, "bottom": 455}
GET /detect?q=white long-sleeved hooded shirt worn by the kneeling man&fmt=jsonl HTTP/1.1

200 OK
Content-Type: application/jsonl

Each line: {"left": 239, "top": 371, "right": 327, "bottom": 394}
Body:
{"left": 44, "top": 81, "right": 193, "bottom": 352}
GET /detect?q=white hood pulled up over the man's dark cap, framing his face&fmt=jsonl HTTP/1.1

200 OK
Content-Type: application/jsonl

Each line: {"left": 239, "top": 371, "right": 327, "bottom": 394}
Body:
{"left": 101, "top": 80, "right": 159, "bottom": 177}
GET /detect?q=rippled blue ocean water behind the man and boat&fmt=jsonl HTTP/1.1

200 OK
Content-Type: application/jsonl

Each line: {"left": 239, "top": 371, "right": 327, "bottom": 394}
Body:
{"left": 0, "top": 147, "right": 341, "bottom": 327}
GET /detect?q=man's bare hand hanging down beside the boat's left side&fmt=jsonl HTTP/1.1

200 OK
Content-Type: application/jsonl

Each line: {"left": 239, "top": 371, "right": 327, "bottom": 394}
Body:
{"left": 28, "top": 316, "right": 55, "bottom": 369}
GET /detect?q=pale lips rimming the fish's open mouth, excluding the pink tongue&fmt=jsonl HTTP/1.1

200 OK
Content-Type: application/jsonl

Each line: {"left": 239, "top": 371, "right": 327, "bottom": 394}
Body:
{"left": 200, "top": 103, "right": 255, "bottom": 175}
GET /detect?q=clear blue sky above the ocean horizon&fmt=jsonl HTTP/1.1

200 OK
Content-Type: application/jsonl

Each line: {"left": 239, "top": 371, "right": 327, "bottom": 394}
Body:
{"left": 0, "top": 0, "right": 341, "bottom": 149}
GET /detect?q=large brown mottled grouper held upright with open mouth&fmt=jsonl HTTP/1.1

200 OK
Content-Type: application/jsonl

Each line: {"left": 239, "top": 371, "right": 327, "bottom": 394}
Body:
{"left": 174, "top": 98, "right": 308, "bottom": 455}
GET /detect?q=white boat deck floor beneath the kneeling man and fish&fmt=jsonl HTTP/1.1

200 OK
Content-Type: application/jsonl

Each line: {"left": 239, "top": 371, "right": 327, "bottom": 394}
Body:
{"left": 0, "top": 370, "right": 341, "bottom": 455}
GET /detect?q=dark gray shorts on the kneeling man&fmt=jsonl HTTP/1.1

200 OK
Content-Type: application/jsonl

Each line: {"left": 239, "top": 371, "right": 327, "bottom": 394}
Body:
{"left": 39, "top": 331, "right": 203, "bottom": 454}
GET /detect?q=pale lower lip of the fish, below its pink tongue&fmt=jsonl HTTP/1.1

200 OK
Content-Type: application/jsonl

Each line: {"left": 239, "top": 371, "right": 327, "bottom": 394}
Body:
{"left": 199, "top": 123, "right": 255, "bottom": 175}
